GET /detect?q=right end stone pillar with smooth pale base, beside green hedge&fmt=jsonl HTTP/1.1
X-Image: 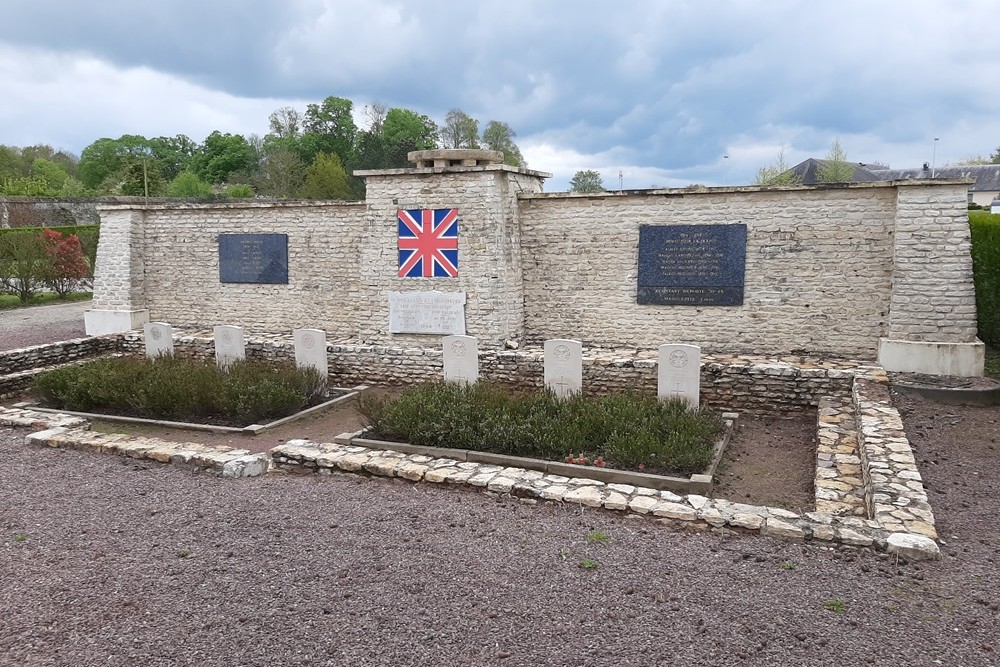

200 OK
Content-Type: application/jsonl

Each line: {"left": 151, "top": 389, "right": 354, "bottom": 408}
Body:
{"left": 879, "top": 181, "right": 985, "bottom": 376}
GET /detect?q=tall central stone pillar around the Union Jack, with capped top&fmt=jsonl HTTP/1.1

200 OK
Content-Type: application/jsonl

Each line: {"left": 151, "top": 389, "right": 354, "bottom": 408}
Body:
{"left": 355, "top": 150, "right": 551, "bottom": 346}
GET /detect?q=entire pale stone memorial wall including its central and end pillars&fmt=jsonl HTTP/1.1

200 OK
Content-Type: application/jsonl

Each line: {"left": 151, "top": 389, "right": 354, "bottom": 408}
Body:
{"left": 87, "top": 151, "right": 983, "bottom": 375}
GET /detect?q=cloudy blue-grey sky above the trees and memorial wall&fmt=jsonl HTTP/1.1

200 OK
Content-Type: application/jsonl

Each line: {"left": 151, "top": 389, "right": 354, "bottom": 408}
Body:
{"left": 0, "top": 0, "right": 1000, "bottom": 191}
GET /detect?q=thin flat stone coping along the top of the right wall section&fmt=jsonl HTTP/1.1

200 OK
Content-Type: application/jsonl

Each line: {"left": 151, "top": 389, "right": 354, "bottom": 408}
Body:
{"left": 520, "top": 177, "right": 975, "bottom": 201}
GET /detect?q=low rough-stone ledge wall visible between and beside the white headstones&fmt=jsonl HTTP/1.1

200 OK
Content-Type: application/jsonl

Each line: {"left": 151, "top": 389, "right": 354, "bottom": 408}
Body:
{"left": 122, "top": 330, "right": 860, "bottom": 415}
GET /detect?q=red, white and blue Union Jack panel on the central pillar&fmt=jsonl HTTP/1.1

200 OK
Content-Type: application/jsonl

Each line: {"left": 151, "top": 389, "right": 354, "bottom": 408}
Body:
{"left": 396, "top": 208, "right": 458, "bottom": 278}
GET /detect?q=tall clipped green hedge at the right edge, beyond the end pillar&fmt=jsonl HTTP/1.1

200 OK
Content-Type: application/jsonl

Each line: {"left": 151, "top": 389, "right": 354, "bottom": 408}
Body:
{"left": 969, "top": 211, "right": 1000, "bottom": 347}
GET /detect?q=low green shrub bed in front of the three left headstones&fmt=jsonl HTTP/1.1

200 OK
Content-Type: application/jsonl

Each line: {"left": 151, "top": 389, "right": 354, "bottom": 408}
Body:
{"left": 34, "top": 357, "right": 323, "bottom": 425}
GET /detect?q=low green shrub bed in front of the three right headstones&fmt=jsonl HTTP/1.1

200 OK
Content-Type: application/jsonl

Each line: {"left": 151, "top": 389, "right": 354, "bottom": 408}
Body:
{"left": 358, "top": 382, "right": 722, "bottom": 474}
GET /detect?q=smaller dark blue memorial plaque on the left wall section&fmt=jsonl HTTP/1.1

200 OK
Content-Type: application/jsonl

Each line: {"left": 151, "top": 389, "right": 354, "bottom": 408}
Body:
{"left": 219, "top": 234, "right": 288, "bottom": 285}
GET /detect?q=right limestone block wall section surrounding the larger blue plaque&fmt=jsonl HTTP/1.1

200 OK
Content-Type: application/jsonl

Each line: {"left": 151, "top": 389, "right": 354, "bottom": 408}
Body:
{"left": 520, "top": 186, "right": 896, "bottom": 358}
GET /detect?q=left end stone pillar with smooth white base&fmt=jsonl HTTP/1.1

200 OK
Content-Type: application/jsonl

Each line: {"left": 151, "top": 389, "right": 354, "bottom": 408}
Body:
{"left": 84, "top": 206, "right": 149, "bottom": 336}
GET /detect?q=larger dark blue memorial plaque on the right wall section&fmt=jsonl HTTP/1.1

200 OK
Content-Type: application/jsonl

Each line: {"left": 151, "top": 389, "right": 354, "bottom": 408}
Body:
{"left": 636, "top": 223, "right": 747, "bottom": 306}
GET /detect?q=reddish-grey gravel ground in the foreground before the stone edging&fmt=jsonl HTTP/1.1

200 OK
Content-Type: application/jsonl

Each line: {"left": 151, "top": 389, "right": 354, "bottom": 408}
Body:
{"left": 0, "top": 394, "right": 1000, "bottom": 666}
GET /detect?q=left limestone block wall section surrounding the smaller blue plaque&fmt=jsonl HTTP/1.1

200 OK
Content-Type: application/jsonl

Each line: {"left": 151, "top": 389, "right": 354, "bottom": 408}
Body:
{"left": 107, "top": 202, "right": 365, "bottom": 337}
